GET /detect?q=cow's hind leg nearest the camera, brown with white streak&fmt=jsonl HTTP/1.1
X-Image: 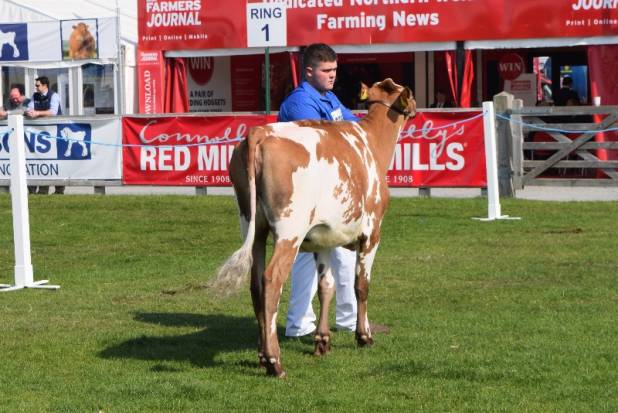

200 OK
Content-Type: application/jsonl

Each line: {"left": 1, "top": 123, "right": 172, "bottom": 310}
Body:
{"left": 262, "top": 240, "right": 298, "bottom": 377}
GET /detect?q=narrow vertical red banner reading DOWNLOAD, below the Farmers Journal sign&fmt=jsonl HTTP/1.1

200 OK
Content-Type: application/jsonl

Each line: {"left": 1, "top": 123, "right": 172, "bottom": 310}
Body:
{"left": 137, "top": 49, "right": 164, "bottom": 114}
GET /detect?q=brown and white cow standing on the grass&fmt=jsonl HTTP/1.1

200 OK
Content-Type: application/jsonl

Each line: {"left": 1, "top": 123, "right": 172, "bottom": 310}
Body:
{"left": 213, "top": 79, "right": 416, "bottom": 377}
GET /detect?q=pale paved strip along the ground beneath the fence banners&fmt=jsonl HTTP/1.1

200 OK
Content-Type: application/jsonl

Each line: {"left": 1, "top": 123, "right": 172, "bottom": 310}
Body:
{"left": 50, "top": 186, "right": 618, "bottom": 201}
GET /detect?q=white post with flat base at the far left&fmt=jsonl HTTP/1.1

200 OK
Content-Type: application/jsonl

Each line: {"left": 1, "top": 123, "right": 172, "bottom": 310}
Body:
{"left": 0, "top": 115, "right": 60, "bottom": 291}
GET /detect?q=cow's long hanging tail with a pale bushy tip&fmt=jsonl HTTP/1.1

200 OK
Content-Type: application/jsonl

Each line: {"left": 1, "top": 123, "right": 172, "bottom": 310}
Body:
{"left": 212, "top": 128, "right": 259, "bottom": 294}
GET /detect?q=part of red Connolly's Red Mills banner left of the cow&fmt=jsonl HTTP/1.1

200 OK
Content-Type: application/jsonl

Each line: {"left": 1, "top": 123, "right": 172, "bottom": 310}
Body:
{"left": 122, "top": 115, "right": 276, "bottom": 186}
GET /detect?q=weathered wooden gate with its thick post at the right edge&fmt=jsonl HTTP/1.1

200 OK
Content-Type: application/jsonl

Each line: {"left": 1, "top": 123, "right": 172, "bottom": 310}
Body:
{"left": 494, "top": 94, "right": 618, "bottom": 191}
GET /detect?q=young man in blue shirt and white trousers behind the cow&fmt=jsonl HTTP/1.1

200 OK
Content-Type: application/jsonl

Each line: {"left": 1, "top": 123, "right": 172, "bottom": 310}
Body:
{"left": 278, "top": 43, "right": 358, "bottom": 337}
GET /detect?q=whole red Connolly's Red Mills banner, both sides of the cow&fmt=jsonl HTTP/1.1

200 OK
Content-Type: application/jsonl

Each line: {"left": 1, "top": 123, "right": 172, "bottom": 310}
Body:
{"left": 123, "top": 112, "right": 486, "bottom": 187}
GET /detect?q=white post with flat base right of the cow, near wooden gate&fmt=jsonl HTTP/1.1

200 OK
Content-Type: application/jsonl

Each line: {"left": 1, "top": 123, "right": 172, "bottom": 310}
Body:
{"left": 475, "top": 102, "right": 519, "bottom": 221}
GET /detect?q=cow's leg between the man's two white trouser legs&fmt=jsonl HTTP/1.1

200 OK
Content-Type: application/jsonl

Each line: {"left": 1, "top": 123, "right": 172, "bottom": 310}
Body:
{"left": 314, "top": 250, "right": 335, "bottom": 356}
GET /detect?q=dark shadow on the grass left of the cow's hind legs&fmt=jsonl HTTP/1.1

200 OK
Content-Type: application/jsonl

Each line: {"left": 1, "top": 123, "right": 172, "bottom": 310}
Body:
{"left": 99, "top": 313, "right": 257, "bottom": 371}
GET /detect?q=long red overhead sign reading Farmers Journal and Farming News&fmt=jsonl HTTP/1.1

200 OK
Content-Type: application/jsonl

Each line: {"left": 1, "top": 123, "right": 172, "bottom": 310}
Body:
{"left": 138, "top": 0, "right": 618, "bottom": 50}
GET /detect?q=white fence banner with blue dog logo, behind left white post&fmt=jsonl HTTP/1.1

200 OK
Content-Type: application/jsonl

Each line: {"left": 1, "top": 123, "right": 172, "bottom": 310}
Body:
{"left": 0, "top": 118, "right": 122, "bottom": 180}
